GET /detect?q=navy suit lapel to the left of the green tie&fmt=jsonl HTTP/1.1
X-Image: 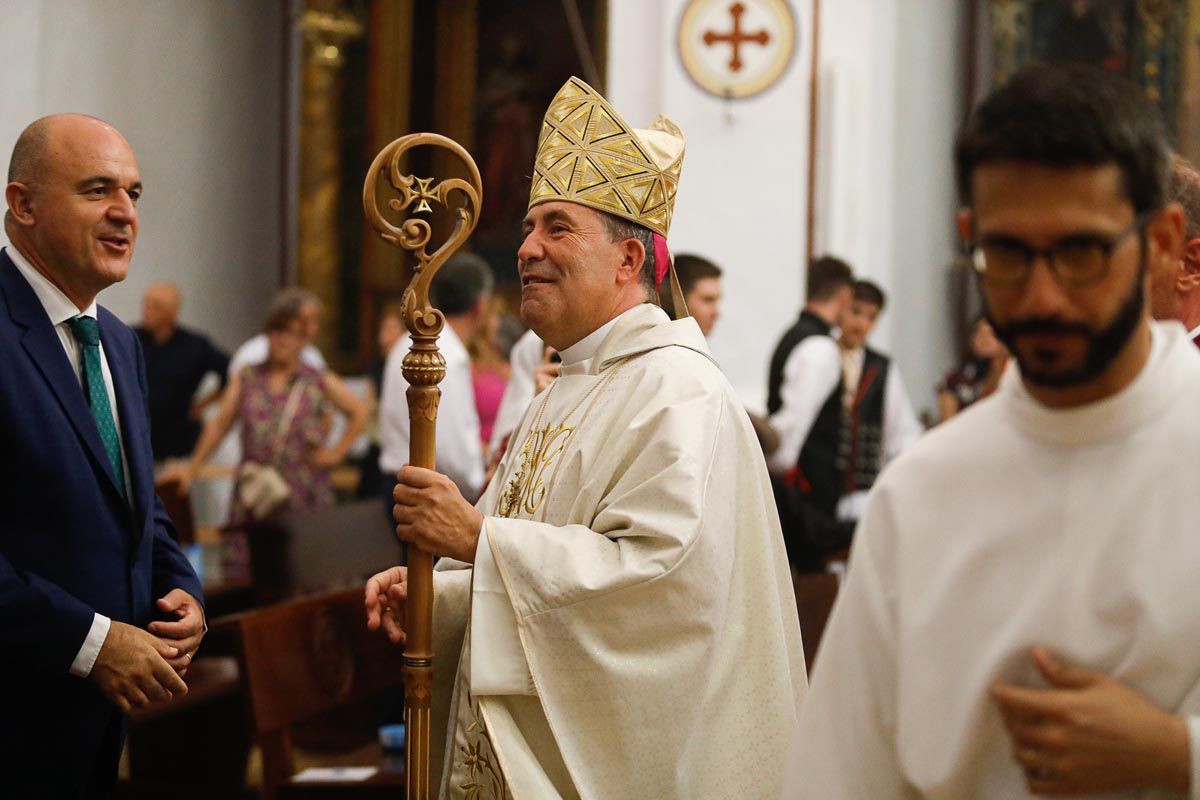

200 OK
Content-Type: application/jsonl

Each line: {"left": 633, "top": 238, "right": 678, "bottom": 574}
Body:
{"left": 0, "top": 253, "right": 128, "bottom": 506}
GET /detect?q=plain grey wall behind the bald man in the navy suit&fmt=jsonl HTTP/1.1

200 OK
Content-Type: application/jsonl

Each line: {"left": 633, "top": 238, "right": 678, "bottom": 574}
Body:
{"left": 0, "top": 0, "right": 284, "bottom": 348}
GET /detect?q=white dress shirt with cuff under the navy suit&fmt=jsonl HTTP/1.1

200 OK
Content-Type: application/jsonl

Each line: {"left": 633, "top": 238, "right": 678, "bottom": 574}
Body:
{"left": 4, "top": 246, "right": 130, "bottom": 678}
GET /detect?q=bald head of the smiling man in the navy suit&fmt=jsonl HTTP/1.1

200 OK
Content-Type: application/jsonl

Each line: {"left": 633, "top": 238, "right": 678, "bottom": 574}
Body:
{"left": 5, "top": 114, "right": 142, "bottom": 308}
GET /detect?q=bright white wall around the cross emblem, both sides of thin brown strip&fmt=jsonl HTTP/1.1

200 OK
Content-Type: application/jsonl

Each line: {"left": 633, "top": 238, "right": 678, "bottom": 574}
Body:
{"left": 607, "top": 0, "right": 965, "bottom": 419}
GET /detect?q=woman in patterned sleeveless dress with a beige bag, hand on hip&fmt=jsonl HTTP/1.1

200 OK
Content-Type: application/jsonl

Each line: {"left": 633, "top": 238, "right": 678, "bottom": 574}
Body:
{"left": 179, "top": 303, "right": 367, "bottom": 524}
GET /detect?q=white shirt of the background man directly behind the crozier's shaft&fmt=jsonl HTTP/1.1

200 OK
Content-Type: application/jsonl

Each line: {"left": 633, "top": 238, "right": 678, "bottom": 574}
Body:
{"left": 379, "top": 325, "right": 484, "bottom": 499}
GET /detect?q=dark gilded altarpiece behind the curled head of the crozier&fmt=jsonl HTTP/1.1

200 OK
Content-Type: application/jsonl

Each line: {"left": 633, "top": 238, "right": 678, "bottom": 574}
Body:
{"left": 293, "top": 0, "right": 607, "bottom": 371}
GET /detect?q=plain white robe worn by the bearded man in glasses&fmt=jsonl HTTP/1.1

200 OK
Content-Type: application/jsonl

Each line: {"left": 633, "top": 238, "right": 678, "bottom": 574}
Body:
{"left": 785, "top": 323, "right": 1200, "bottom": 800}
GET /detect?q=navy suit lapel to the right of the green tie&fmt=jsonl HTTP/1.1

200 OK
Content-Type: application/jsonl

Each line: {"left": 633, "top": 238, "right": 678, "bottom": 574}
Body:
{"left": 98, "top": 309, "right": 154, "bottom": 539}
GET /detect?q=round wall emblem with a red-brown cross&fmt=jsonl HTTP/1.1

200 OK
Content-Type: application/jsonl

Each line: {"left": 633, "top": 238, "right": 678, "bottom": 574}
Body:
{"left": 679, "top": 0, "right": 796, "bottom": 98}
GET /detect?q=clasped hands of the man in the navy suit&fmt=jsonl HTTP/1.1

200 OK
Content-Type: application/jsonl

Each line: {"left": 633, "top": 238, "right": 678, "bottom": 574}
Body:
{"left": 88, "top": 589, "right": 204, "bottom": 712}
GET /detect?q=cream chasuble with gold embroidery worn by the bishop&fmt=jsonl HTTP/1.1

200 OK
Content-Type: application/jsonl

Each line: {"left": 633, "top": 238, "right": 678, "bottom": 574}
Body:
{"left": 434, "top": 305, "right": 806, "bottom": 800}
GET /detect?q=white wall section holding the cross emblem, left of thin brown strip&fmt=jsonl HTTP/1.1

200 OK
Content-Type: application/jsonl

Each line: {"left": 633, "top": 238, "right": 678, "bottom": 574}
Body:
{"left": 607, "top": 0, "right": 811, "bottom": 410}
